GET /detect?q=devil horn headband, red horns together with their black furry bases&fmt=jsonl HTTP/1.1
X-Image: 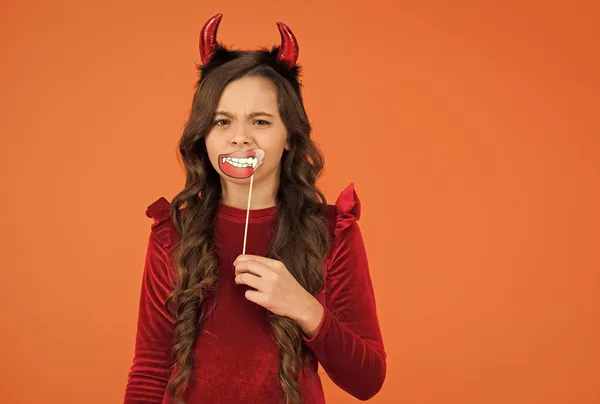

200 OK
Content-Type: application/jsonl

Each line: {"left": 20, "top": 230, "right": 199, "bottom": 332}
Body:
{"left": 200, "top": 13, "right": 300, "bottom": 93}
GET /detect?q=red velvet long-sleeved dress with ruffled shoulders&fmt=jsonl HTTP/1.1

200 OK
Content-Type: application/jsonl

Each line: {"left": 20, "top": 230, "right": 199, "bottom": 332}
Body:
{"left": 125, "top": 185, "right": 386, "bottom": 404}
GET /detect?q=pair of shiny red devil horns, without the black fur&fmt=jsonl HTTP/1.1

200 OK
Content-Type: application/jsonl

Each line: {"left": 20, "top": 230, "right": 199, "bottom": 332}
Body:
{"left": 200, "top": 13, "right": 299, "bottom": 69}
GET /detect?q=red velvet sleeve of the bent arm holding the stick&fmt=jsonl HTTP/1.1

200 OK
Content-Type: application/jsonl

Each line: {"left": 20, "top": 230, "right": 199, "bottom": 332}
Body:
{"left": 303, "top": 184, "right": 387, "bottom": 400}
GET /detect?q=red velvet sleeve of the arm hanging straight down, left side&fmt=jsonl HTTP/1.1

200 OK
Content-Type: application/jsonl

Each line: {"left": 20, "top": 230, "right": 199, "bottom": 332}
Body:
{"left": 124, "top": 198, "right": 175, "bottom": 404}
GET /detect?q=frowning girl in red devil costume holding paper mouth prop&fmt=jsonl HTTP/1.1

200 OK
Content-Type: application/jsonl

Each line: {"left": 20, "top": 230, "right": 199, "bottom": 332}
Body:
{"left": 125, "top": 14, "right": 386, "bottom": 404}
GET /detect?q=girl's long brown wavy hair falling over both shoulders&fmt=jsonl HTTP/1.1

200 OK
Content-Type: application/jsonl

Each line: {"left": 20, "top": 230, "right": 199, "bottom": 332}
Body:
{"left": 167, "top": 51, "right": 329, "bottom": 404}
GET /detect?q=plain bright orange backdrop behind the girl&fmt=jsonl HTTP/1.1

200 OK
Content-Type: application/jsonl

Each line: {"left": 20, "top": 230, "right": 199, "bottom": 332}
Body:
{"left": 0, "top": 0, "right": 600, "bottom": 404}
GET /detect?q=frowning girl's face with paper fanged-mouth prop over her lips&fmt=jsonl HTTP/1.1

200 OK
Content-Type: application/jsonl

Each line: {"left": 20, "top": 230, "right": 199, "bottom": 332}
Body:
{"left": 205, "top": 76, "right": 288, "bottom": 184}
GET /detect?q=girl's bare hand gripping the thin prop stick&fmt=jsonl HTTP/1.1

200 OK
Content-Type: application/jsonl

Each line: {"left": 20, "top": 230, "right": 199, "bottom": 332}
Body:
{"left": 233, "top": 254, "right": 324, "bottom": 338}
